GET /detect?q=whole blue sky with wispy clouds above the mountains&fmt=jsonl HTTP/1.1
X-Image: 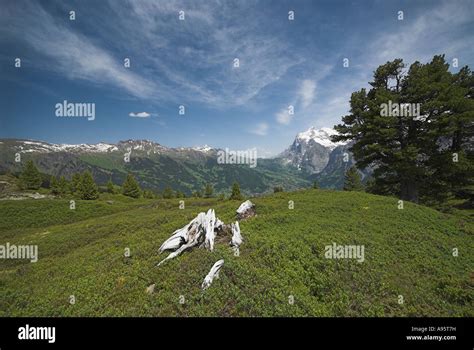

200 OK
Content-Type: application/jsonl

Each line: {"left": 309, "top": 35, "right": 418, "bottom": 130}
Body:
{"left": 0, "top": 0, "right": 474, "bottom": 156}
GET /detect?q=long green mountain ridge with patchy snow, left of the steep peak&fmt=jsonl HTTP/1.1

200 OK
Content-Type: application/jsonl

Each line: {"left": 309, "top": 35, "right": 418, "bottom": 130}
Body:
{"left": 0, "top": 139, "right": 310, "bottom": 195}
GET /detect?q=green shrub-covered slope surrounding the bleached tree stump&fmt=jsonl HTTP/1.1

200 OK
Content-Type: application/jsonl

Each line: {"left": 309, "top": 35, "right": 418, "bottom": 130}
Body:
{"left": 0, "top": 190, "right": 474, "bottom": 316}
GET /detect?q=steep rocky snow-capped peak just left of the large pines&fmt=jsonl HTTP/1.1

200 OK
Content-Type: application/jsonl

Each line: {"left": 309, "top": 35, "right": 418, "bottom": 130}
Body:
{"left": 279, "top": 127, "right": 347, "bottom": 174}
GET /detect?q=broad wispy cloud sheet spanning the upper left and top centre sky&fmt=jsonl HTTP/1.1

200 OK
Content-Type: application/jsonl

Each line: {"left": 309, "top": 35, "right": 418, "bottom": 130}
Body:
{"left": 0, "top": 0, "right": 303, "bottom": 108}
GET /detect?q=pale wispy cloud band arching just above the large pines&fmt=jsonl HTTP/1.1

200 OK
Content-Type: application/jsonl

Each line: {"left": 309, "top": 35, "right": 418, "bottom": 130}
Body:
{"left": 308, "top": 1, "right": 474, "bottom": 127}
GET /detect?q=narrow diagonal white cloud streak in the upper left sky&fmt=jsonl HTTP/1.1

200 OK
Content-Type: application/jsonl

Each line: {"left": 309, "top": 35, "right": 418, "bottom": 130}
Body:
{"left": 2, "top": 3, "right": 162, "bottom": 98}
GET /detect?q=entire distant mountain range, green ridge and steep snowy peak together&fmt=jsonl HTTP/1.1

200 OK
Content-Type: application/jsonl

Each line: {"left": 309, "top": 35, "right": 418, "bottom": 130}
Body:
{"left": 0, "top": 128, "right": 364, "bottom": 195}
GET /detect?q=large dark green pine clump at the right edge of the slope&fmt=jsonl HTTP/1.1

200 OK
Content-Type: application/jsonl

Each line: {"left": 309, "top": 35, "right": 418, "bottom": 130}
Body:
{"left": 333, "top": 56, "right": 474, "bottom": 202}
